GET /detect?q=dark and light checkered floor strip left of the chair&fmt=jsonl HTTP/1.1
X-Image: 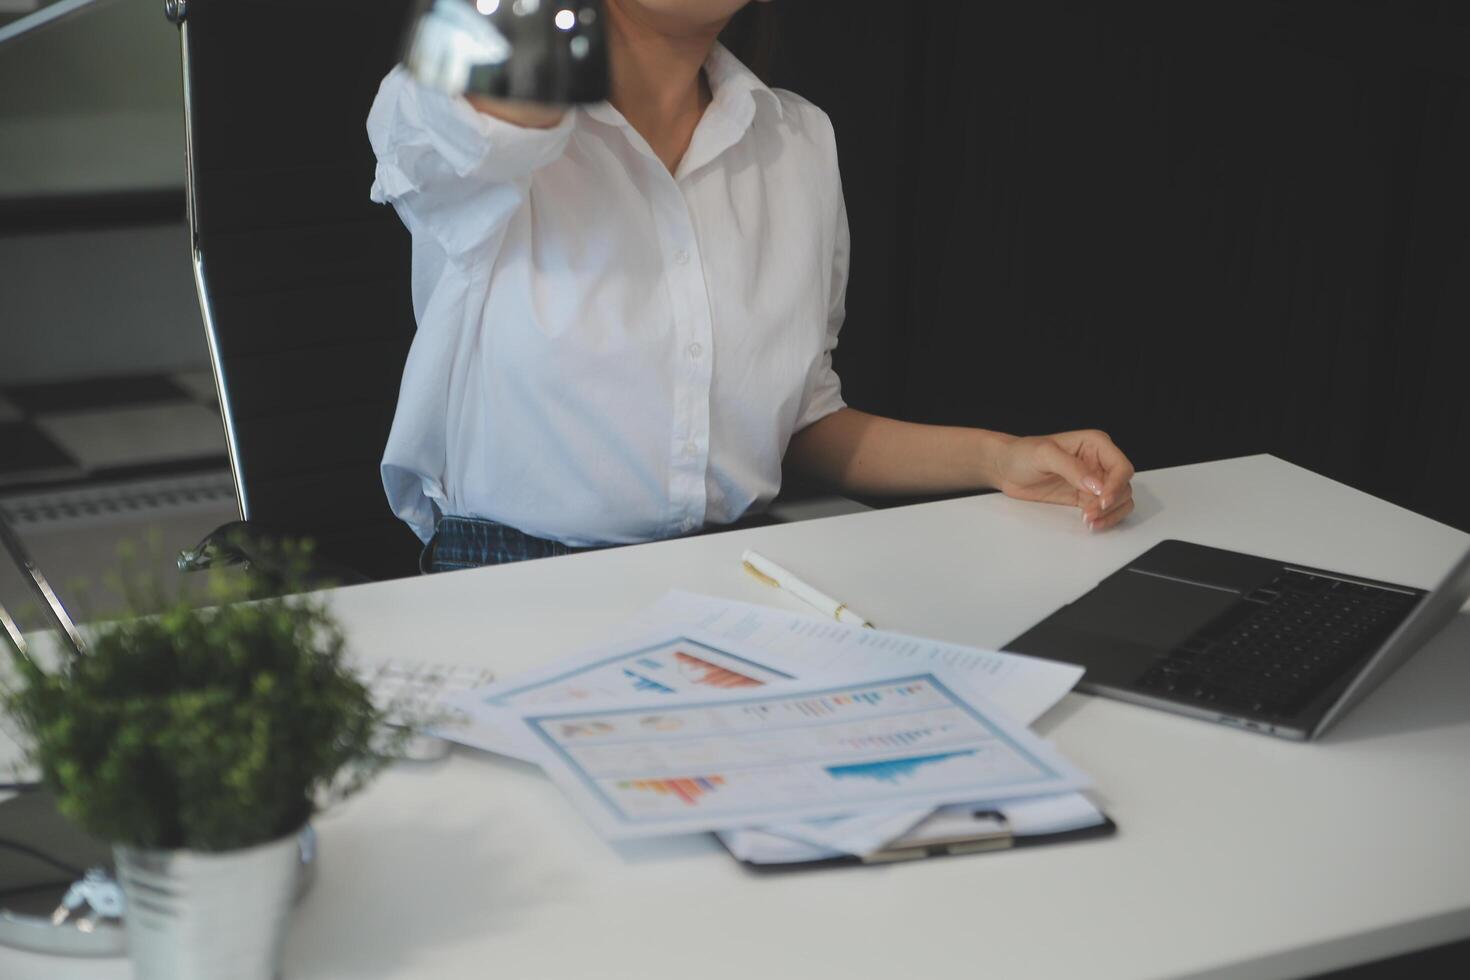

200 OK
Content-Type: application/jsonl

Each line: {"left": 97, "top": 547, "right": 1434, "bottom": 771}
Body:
{"left": 0, "top": 372, "right": 228, "bottom": 491}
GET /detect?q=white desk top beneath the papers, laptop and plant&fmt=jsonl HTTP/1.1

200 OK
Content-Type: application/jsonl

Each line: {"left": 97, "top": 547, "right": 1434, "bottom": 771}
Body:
{"left": 0, "top": 457, "right": 1470, "bottom": 980}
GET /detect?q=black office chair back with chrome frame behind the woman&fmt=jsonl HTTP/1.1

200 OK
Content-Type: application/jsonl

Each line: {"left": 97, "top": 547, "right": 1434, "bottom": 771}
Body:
{"left": 166, "top": 0, "right": 419, "bottom": 582}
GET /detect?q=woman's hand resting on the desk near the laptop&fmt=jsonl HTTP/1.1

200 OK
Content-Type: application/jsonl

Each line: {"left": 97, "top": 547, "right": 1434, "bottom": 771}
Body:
{"left": 994, "top": 429, "right": 1133, "bottom": 530}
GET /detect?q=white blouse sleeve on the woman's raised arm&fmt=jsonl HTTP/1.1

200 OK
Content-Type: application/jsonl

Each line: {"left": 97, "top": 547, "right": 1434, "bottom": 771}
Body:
{"left": 368, "top": 66, "right": 575, "bottom": 262}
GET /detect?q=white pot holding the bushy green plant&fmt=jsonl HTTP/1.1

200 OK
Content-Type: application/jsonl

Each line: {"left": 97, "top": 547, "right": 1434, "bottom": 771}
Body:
{"left": 113, "top": 832, "right": 303, "bottom": 980}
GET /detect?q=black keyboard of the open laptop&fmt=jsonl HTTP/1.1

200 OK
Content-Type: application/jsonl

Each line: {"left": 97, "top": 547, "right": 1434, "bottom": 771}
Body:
{"left": 1138, "top": 570, "right": 1419, "bottom": 717}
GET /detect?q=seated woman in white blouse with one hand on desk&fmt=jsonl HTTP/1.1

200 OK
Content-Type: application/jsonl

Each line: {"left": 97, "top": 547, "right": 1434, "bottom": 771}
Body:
{"left": 368, "top": 0, "right": 1133, "bottom": 570}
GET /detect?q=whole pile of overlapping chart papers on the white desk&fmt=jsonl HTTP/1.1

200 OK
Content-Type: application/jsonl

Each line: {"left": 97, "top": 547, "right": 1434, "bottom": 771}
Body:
{"left": 442, "top": 592, "right": 1103, "bottom": 864}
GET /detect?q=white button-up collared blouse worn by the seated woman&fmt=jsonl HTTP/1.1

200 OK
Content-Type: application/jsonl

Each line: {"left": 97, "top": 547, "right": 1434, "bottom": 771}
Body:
{"left": 368, "top": 46, "right": 848, "bottom": 545}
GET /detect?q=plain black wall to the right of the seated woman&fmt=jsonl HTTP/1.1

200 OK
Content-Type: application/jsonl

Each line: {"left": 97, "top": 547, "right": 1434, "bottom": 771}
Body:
{"left": 770, "top": 0, "right": 1470, "bottom": 530}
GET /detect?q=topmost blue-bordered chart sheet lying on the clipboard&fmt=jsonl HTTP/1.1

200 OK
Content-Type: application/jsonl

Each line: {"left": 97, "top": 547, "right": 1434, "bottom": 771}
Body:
{"left": 515, "top": 671, "right": 1088, "bottom": 837}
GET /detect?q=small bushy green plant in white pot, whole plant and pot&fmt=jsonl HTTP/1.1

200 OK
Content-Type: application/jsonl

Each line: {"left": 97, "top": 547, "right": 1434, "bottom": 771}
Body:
{"left": 4, "top": 558, "right": 384, "bottom": 980}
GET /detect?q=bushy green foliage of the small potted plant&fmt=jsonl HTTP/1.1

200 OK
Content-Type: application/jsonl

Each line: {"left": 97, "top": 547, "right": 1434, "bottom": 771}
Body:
{"left": 4, "top": 549, "right": 382, "bottom": 851}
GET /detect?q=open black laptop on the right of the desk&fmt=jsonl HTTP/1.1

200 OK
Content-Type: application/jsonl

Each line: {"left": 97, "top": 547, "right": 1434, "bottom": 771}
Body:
{"left": 1004, "top": 541, "right": 1470, "bottom": 739}
